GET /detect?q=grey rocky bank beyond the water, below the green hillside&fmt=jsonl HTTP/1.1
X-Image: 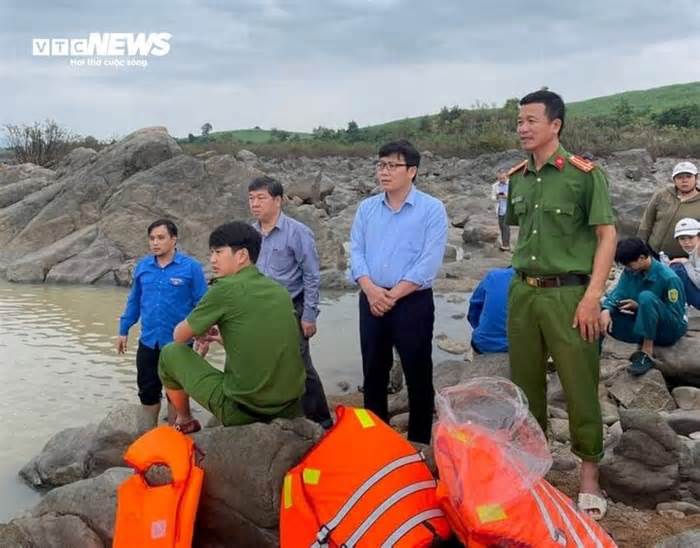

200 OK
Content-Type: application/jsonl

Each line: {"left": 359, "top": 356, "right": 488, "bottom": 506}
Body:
{"left": 0, "top": 127, "right": 696, "bottom": 291}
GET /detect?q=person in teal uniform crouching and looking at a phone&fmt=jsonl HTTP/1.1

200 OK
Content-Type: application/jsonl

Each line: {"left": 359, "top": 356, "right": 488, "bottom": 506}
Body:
{"left": 600, "top": 238, "right": 688, "bottom": 375}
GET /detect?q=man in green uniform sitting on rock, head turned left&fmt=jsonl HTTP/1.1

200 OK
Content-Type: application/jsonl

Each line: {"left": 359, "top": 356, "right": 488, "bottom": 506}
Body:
{"left": 159, "top": 222, "right": 305, "bottom": 433}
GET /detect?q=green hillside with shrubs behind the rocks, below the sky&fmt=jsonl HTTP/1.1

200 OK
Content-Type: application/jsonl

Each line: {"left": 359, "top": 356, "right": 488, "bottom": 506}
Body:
{"left": 181, "top": 82, "right": 700, "bottom": 157}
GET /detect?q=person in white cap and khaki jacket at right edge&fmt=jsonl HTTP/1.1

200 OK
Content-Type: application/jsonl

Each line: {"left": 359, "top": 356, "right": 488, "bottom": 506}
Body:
{"left": 637, "top": 162, "right": 700, "bottom": 259}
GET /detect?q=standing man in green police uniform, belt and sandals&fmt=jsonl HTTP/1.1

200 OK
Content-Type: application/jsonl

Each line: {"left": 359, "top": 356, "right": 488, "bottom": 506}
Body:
{"left": 507, "top": 90, "right": 616, "bottom": 519}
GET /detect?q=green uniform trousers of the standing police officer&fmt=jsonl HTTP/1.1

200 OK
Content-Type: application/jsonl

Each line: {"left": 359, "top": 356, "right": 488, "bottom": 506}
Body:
{"left": 508, "top": 274, "right": 603, "bottom": 461}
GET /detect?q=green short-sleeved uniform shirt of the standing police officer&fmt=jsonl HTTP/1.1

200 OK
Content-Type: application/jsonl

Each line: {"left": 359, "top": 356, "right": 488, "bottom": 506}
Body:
{"left": 506, "top": 146, "right": 615, "bottom": 276}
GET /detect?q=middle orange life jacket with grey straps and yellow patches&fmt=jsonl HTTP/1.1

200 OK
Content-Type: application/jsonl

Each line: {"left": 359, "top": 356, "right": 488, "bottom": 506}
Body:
{"left": 280, "top": 406, "right": 450, "bottom": 548}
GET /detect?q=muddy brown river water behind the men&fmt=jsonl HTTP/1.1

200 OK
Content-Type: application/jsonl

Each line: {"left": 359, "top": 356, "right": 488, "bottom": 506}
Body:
{"left": 0, "top": 281, "right": 468, "bottom": 521}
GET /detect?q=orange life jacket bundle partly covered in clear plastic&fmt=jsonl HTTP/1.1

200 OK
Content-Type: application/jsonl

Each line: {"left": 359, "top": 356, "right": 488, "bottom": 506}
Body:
{"left": 433, "top": 378, "right": 615, "bottom": 548}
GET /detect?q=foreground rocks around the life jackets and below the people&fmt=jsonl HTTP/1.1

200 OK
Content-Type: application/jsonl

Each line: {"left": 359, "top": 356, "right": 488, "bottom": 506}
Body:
{"left": 5, "top": 318, "right": 700, "bottom": 548}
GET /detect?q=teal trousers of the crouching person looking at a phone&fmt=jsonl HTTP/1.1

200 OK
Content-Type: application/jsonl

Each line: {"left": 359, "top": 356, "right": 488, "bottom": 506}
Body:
{"left": 610, "top": 291, "right": 688, "bottom": 346}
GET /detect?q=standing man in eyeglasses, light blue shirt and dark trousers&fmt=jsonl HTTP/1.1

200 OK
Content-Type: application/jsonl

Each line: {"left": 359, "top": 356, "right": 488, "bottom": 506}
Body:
{"left": 350, "top": 141, "right": 447, "bottom": 443}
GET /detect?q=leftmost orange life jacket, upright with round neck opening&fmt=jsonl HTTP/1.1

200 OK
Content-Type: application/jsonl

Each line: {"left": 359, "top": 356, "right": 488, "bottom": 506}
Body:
{"left": 112, "top": 426, "right": 204, "bottom": 548}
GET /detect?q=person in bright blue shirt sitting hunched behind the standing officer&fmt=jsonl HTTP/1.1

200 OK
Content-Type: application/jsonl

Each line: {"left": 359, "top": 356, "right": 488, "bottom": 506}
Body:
{"left": 467, "top": 266, "right": 515, "bottom": 354}
